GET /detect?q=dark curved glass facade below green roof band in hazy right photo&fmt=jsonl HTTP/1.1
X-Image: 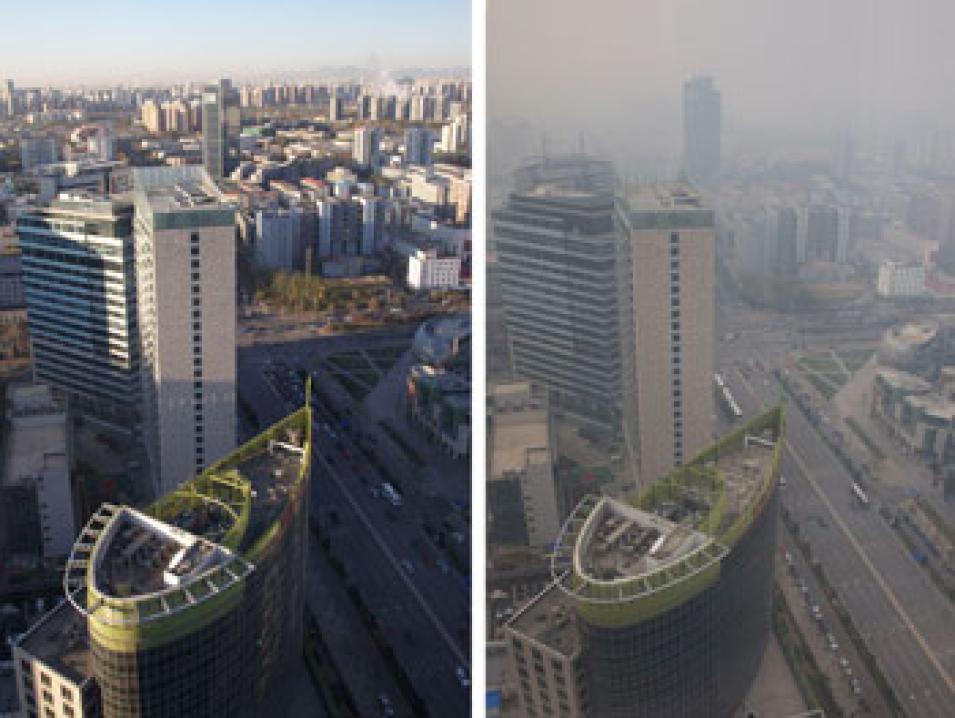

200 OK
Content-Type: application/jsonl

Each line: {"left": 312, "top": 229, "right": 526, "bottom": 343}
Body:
{"left": 579, "top": 490, "right": 778, "bottom": 718}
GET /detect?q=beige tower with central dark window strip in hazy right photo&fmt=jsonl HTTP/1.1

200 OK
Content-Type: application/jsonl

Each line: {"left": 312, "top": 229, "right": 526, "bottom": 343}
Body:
{"left": 620, "top": 186, "right": 715, "bottom": 483}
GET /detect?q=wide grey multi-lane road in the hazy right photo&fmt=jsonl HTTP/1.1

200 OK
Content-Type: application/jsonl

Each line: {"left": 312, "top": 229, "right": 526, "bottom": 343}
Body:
{"left": 720, "top": 306, "right": 955, "bottom": 718}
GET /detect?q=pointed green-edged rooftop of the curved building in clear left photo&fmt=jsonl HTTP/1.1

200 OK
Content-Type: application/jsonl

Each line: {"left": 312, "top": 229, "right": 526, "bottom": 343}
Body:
{"left": 64, "top": 408, "right": 309, "bottom": 625}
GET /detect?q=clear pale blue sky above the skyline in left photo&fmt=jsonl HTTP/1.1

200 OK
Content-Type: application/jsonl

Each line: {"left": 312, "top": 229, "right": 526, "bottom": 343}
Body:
{"left": 0, "top": 0, "right": 471, "bottom": 86}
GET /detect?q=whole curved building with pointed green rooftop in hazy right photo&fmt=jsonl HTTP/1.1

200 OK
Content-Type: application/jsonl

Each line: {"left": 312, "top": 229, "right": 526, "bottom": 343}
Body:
{"left": 505, "top": 407, "right": 783, "bottom": 718}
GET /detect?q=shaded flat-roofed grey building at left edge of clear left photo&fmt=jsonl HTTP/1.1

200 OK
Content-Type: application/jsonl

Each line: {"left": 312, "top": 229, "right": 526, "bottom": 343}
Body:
{"left": 3, "top": 384, "right": 76, "bottom": 559}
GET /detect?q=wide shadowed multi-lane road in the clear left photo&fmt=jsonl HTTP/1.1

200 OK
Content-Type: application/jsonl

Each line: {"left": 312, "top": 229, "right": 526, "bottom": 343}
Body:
{"left": 239, "top": 338, "right": 470, "bottom": 716}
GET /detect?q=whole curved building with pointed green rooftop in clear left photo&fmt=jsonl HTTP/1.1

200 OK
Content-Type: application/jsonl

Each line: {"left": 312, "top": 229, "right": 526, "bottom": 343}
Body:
{"left": 13, "top": 406, "right": 311, "bottom": 718}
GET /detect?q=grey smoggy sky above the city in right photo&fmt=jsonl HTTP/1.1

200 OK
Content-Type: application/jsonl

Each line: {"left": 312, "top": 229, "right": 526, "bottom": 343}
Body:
{"left": 487, "top": 0, "right": 955, "bottom": 156}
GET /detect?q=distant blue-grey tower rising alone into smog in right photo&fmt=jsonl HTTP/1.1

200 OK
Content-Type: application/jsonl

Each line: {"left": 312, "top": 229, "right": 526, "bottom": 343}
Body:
{"left": 683, "top": 77, "right": 722, "bottom": 187}
